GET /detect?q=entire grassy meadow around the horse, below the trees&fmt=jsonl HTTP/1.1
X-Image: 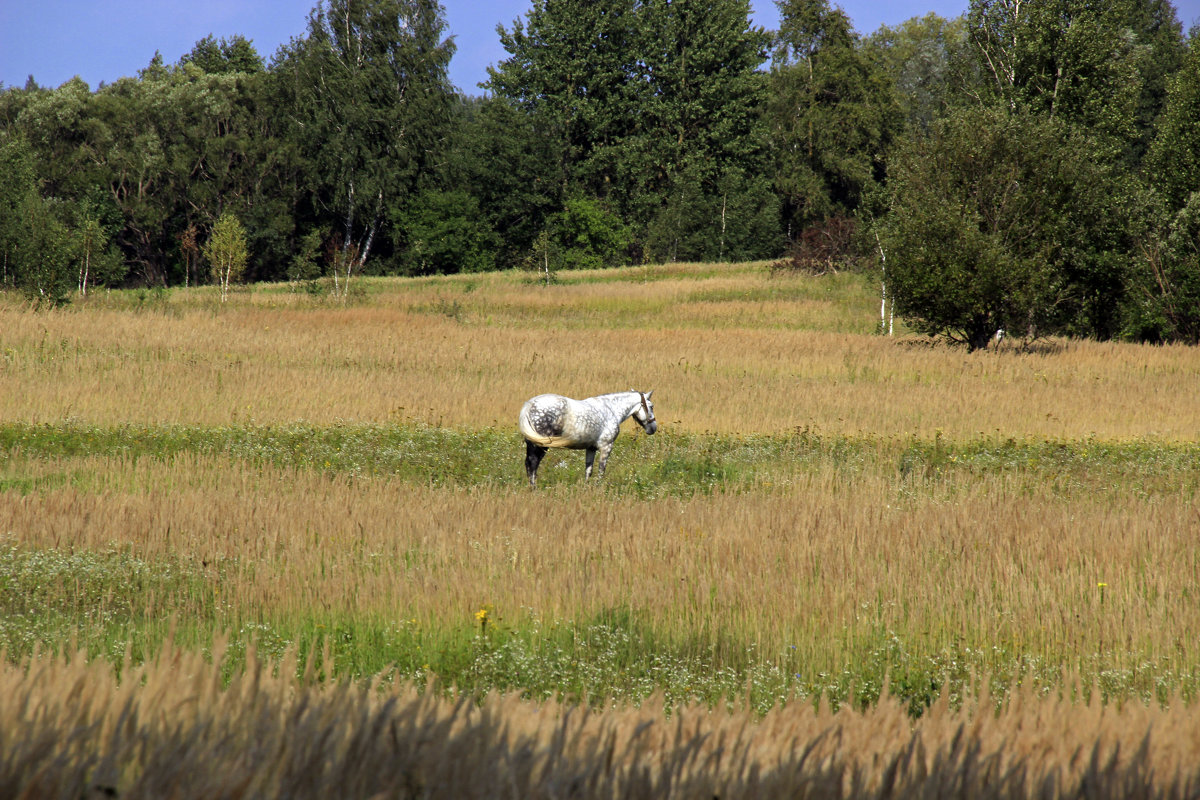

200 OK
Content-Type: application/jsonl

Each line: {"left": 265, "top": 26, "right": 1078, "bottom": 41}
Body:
{"left": 0, "top": 264, "right": 1200, "bottom": 796}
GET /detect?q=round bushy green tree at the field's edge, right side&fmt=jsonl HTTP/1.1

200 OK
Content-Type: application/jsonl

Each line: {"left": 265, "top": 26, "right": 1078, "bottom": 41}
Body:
{"left": 880, "top": 108, "right": 1121, "bottom": 350}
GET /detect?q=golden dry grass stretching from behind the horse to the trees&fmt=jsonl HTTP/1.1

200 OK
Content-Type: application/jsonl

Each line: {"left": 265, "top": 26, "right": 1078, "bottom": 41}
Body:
{"left": 0, "top": 267, "right": 1200, "bottom": 441}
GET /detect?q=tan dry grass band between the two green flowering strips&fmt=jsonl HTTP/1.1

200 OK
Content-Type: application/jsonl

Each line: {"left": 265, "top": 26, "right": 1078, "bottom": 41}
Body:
{"left": 0, "top": 455, "right": 1200, "bottom": 696}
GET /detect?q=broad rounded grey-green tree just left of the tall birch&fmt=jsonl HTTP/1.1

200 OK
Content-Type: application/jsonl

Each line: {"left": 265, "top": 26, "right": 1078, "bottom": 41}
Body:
{"left": 82, "top": 62, "right": 276, "bottom": 284}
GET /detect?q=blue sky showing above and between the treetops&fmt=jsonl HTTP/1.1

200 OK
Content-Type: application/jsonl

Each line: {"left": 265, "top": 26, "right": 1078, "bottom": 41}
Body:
{"left": 7, "top": 0, "right": 1200, "bottom": 92}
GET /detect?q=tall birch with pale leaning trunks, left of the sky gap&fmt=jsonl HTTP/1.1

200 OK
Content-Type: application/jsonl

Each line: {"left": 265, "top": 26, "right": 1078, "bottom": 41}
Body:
{"left": 276, "top": 0, "right": 454, "bottom": 272}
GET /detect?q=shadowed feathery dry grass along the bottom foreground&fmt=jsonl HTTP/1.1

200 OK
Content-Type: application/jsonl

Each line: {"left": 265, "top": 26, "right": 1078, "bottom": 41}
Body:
{"left": 0, "top": 644, "right": 1200, "bottom": 800}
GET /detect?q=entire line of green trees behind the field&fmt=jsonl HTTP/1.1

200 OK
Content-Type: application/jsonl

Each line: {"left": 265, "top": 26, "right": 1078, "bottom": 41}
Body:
{"left": 0, "top": 0, "right": 1200, "bottom": 349}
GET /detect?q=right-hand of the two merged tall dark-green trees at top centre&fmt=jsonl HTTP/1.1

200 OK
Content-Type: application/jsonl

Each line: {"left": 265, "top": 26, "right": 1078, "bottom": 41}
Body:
{"left": 625, "top": 0, "right": 779, "bottom": 260}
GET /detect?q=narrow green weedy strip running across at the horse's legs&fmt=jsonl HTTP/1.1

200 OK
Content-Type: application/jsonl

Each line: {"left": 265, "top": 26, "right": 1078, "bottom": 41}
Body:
{"left": 0, "top": 423, "right": 1200, "bottom": 499}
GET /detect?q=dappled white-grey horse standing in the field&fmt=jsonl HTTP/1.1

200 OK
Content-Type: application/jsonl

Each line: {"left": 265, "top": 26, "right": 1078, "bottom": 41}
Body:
{"left": 517, "top": 389, "right": 659, "bottom": 487}
